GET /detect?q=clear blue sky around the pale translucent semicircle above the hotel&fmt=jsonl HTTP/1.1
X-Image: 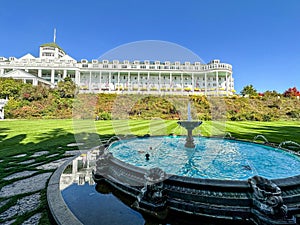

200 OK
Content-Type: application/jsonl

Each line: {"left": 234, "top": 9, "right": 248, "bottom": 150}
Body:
{"left": 0, "top": 0, "right": 300, "bottom": 92}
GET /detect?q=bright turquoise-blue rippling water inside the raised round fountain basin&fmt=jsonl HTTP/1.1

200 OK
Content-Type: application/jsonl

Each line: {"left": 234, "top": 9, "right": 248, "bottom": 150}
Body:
{"left": 109, "top": 136, "right": 300, "bottom": 180}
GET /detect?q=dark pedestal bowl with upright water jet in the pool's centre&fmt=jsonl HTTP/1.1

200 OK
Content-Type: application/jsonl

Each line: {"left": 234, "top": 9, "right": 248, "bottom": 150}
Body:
{"left": 177, "top": 102, "right": 202, "bottom": 148}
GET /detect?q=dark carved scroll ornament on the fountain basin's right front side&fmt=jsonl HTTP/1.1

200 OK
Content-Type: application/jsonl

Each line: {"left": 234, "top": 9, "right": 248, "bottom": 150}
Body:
{"left": 248, "top": 176, "right": 288, "bottom": 218}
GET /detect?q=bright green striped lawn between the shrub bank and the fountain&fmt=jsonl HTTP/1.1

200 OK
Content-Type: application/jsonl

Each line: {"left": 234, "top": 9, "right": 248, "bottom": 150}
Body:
{"left": 0, "top": 119, "right": 300, "bottom": 158}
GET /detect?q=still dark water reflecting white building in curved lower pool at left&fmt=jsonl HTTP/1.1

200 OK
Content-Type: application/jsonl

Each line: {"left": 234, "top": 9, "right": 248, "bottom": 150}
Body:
{"left": 60, "top": 150, "right": 147, "bottom": 225}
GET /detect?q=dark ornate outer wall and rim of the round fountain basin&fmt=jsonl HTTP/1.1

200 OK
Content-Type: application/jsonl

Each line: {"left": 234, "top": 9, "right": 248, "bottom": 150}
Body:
{"left": 93, "top": 137, "right": 300, "bottom": 224}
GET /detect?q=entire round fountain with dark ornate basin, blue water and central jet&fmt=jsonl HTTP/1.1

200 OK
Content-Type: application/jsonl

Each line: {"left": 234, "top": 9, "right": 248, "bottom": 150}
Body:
{"left": 93, "top": 104, "right": 300, "bottom": 225}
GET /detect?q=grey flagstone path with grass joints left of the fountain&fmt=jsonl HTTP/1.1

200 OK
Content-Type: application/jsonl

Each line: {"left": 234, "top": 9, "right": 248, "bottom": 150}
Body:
{"left": 0, "top": 151, "right": 78, "bottom": 225}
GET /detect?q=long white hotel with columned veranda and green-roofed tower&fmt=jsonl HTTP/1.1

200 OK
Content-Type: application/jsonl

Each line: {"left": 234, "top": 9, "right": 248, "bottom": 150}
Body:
{"left": 0, "top": 42, "right": 235, "bottom": 96}
